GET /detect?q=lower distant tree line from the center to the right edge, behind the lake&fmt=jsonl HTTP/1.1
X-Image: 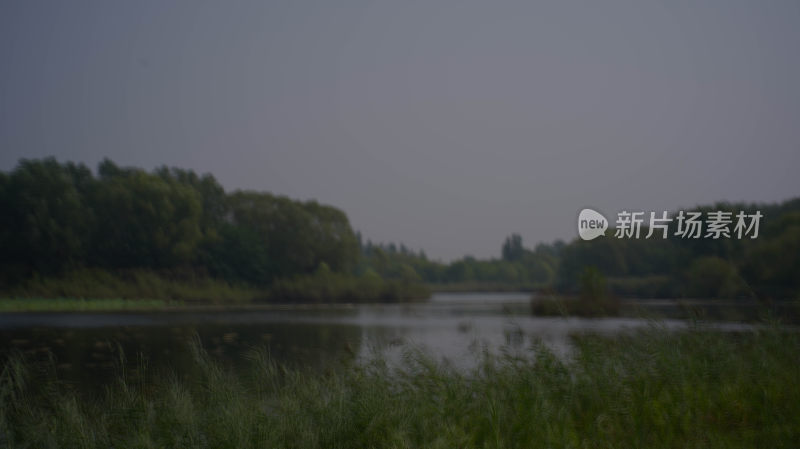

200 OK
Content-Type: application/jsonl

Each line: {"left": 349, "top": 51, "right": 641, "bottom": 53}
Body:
{"left": 361, "top": 198, "right": 800, "bottom": 300}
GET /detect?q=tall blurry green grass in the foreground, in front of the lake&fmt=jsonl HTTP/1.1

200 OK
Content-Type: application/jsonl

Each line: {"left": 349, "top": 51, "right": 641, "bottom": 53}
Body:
{"left": 0, "top": 328, "right": 800, "bottom": 448}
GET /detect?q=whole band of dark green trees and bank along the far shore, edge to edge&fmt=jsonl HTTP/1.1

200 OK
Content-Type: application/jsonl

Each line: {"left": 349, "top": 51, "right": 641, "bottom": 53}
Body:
{"left": 0, "top": 158, "right": 800, "bottom": 301}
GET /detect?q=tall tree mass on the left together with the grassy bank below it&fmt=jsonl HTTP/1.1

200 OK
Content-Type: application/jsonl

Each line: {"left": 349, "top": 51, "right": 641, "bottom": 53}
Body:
{"left": 0, "top": 158, "right": 427, "bottom": 301}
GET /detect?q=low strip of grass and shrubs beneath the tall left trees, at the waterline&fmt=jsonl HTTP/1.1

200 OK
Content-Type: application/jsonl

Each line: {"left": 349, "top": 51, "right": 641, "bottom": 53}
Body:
{"left": 0, "top": 269, "right": 430, "bottom": 311}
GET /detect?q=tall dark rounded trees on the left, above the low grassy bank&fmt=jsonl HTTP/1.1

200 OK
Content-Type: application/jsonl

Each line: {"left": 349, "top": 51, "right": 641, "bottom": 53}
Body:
{"left": 0, "top": 158, "right": 358, "bottom": 294}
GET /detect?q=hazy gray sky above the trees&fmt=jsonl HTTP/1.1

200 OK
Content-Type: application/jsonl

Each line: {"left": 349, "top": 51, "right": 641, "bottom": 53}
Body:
{"left": 0, "top": 0, "right": 800, "bottom": 260}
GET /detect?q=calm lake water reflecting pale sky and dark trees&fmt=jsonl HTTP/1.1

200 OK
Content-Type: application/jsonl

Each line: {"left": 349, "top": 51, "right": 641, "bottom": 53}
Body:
{"left": 0, "top": 293, "right": 747, "bottom": 388}
